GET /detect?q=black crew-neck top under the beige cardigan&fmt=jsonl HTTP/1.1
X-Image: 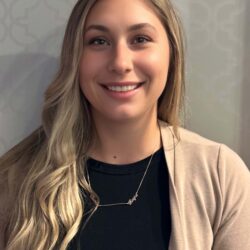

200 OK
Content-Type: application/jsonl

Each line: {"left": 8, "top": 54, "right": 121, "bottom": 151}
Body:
{"left": 68, "top": 148, "right": 171, "bottom": 250}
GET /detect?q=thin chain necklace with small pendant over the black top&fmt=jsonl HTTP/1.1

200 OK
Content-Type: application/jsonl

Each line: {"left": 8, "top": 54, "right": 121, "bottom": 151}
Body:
{"left": 86, "top": 150, "right": 156, "bottom": 207}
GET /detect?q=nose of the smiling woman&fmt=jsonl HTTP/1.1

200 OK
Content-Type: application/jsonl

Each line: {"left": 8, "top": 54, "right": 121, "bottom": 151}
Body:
{"left": 108, "top": 41, "right": 133, "bottom": 75}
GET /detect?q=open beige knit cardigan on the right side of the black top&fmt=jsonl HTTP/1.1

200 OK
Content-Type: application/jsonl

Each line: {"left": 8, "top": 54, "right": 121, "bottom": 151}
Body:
{"left": 160, "top": 122, "right": 250, "bottom": 250}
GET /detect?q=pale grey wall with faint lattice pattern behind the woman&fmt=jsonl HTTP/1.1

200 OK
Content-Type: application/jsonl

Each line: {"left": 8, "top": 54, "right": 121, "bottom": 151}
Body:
{"left": 0, "top": 0, "right": 250, "bottom": 166}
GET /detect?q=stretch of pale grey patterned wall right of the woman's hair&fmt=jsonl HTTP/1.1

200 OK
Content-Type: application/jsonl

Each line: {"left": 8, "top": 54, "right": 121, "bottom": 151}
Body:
{"left": 176, "top": 0, "right": 250, "bottom": 166}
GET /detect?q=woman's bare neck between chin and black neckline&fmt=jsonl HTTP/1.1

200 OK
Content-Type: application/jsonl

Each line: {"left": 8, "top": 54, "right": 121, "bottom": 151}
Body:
{"left": 90, "top": 113, "right": 161, "bottom": 164}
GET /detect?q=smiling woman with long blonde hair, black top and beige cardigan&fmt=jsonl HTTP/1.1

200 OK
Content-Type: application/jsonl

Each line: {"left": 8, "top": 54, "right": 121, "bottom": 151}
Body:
{"left": 0, "top": 0, "right": 250, "bottom": 250}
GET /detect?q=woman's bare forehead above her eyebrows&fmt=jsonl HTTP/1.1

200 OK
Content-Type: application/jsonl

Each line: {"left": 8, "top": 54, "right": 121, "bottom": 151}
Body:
{"left": 85, "top": 0, "right": 164, "bottom": 29}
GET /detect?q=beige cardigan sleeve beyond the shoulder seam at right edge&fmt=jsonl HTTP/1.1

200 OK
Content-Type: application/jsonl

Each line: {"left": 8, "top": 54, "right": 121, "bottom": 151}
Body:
{"left": 213, "top": 145, "right": 250, "bottom": 250}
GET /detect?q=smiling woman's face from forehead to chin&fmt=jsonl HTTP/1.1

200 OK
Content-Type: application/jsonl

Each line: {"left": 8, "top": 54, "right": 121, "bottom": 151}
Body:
{"left": 80, "top": 0, "right": 169, "bottom": 122}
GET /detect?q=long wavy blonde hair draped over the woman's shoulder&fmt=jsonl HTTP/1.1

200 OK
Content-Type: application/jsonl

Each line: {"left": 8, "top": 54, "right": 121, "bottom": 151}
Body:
{"left": 0, "top": 0, "right": 184, "bottom": 250}
